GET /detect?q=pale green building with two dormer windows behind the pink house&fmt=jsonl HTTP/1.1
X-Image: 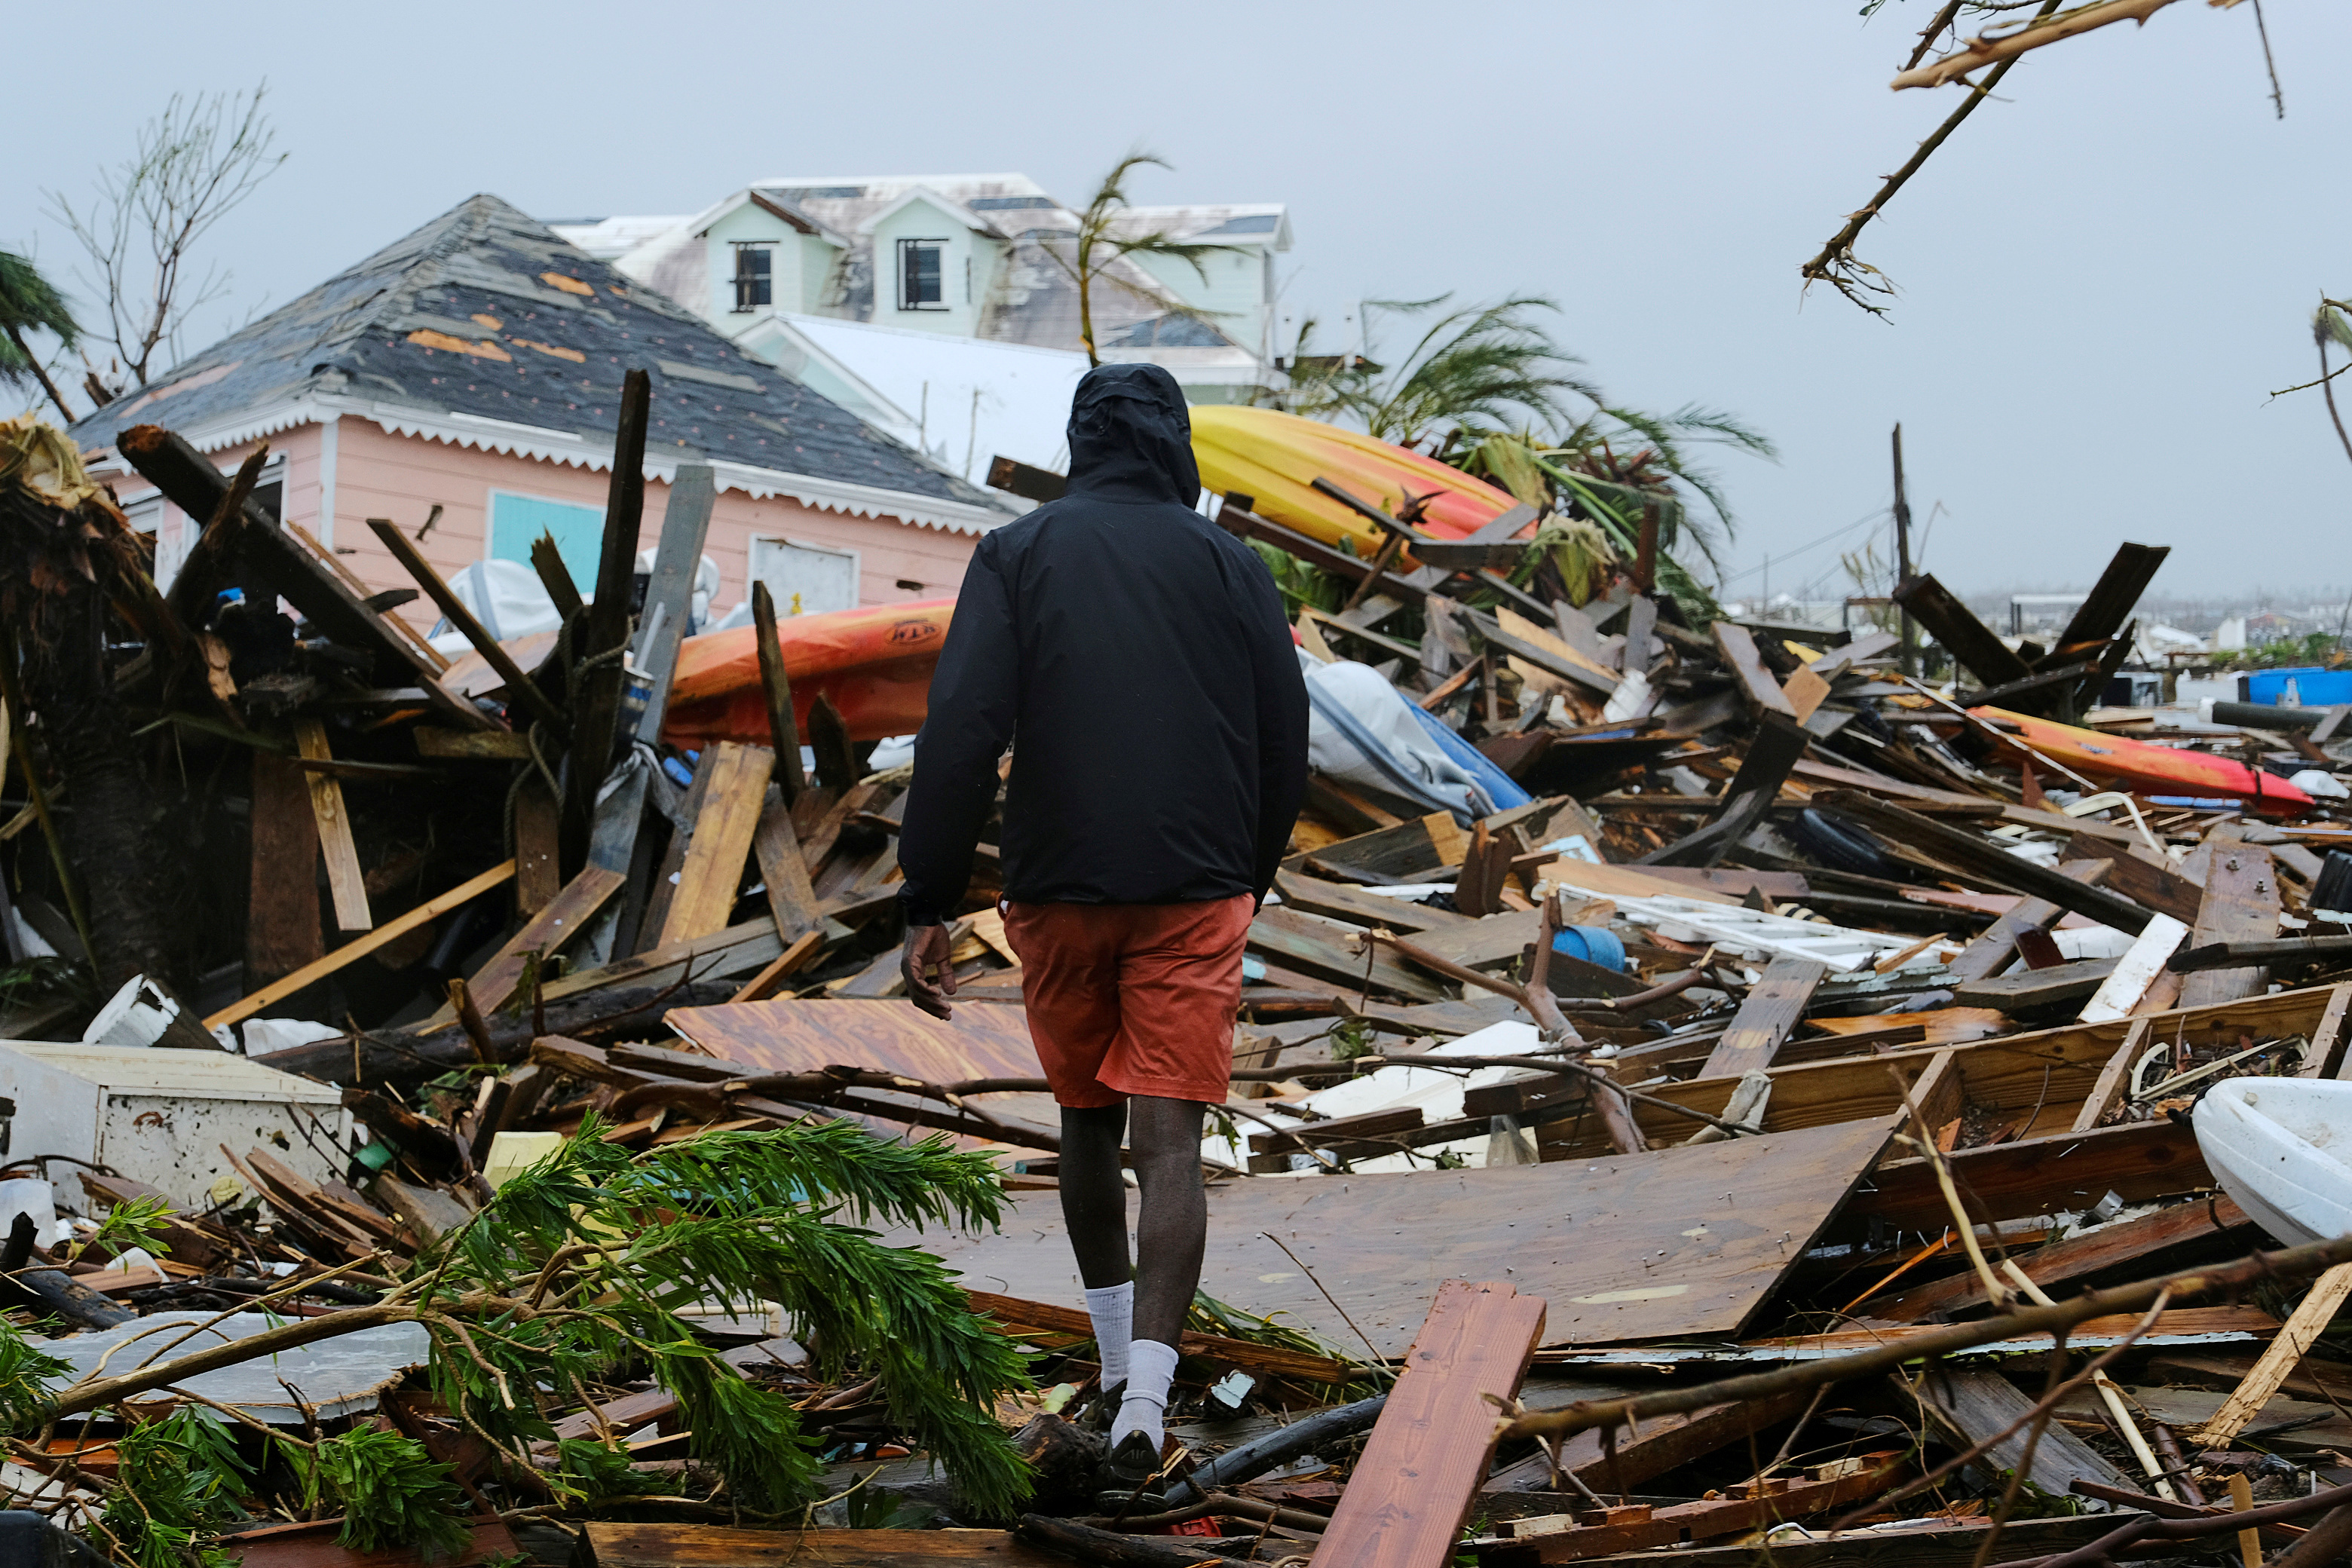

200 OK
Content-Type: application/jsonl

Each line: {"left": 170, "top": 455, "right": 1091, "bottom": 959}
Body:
{"left": 553, "top": 174, "right": 1291, "bottom": 409}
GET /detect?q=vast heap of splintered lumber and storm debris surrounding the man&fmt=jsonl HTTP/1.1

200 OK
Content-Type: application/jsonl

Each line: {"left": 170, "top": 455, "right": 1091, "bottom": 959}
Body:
{"left": 0, "top": 394, "right": 2352, "bottom": 1568}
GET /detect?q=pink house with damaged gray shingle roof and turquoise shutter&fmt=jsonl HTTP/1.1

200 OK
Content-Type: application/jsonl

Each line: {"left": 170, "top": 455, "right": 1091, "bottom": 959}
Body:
{"left": 73, "top": 195, "right": 1012, "bottom": 630}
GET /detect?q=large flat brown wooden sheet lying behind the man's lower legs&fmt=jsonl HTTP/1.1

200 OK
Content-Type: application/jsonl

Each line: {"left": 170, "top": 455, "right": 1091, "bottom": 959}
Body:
{"left": 884, "top": 1114, "right": 1894, "bottom": 1356}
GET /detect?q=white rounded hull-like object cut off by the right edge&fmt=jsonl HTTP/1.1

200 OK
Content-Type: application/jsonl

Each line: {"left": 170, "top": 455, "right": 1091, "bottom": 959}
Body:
{"left": 2192, "top": 1079, "right": 2352, "bottom": 1246}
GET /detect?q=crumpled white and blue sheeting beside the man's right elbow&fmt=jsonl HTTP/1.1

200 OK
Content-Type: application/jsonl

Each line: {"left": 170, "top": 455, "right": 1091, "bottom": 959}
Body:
{"left": 1298, "top": 654, "right": 1529, "bottom": 825}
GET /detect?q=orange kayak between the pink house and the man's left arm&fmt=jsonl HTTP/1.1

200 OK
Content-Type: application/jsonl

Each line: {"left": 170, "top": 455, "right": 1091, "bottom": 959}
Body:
{"left": 661, "top": 599, "right": 955, "bottom": 750}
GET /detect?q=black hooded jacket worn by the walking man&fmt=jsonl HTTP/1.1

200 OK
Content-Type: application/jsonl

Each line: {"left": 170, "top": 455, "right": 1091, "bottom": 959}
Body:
{"left": 899, "top": 364, "right": 1308, "bottom": 924}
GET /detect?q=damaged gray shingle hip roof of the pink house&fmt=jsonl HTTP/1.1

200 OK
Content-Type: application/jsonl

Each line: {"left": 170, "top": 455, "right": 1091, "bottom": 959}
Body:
{"left": 73, "top": 195, "right": 1002, "bottom": 510}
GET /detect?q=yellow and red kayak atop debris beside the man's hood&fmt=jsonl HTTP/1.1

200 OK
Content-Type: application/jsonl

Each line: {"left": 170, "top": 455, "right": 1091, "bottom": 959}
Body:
{"left": 1193, "top": 404, "right": 1520, "bottom": 555}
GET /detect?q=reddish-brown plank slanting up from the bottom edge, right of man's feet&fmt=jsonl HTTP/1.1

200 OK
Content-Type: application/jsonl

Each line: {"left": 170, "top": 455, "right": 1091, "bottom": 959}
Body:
{"left": 1315, "top": 1279, "right": 1543, "bottom": 1568}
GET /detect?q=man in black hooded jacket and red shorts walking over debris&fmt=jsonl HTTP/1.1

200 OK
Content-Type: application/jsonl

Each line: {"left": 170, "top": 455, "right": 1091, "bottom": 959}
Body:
{"left": 899, "top": 364, "right": 1308, "bottom": 1500}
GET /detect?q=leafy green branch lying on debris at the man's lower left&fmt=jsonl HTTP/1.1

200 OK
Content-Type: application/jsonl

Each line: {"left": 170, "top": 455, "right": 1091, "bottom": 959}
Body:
{"left": 426, "top": 1121, "right": 1027, "bottom": 1511}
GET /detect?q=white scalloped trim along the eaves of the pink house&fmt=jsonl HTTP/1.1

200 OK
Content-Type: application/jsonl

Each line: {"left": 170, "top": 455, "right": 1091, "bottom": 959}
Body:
{"left": 78, "top": 395, "right": 1014, "bottom": 534}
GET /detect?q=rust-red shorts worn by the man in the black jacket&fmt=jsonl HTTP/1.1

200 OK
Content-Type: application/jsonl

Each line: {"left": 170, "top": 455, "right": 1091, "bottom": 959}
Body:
{"left": 1004, "top": 893, "right": 1256, "bottom": 1110}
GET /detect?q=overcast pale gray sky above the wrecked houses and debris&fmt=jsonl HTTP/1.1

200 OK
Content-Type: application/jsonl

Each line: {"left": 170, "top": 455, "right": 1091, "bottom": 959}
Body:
{"left": 0, "top": 0, "right": 2352, "bottom": 604}
